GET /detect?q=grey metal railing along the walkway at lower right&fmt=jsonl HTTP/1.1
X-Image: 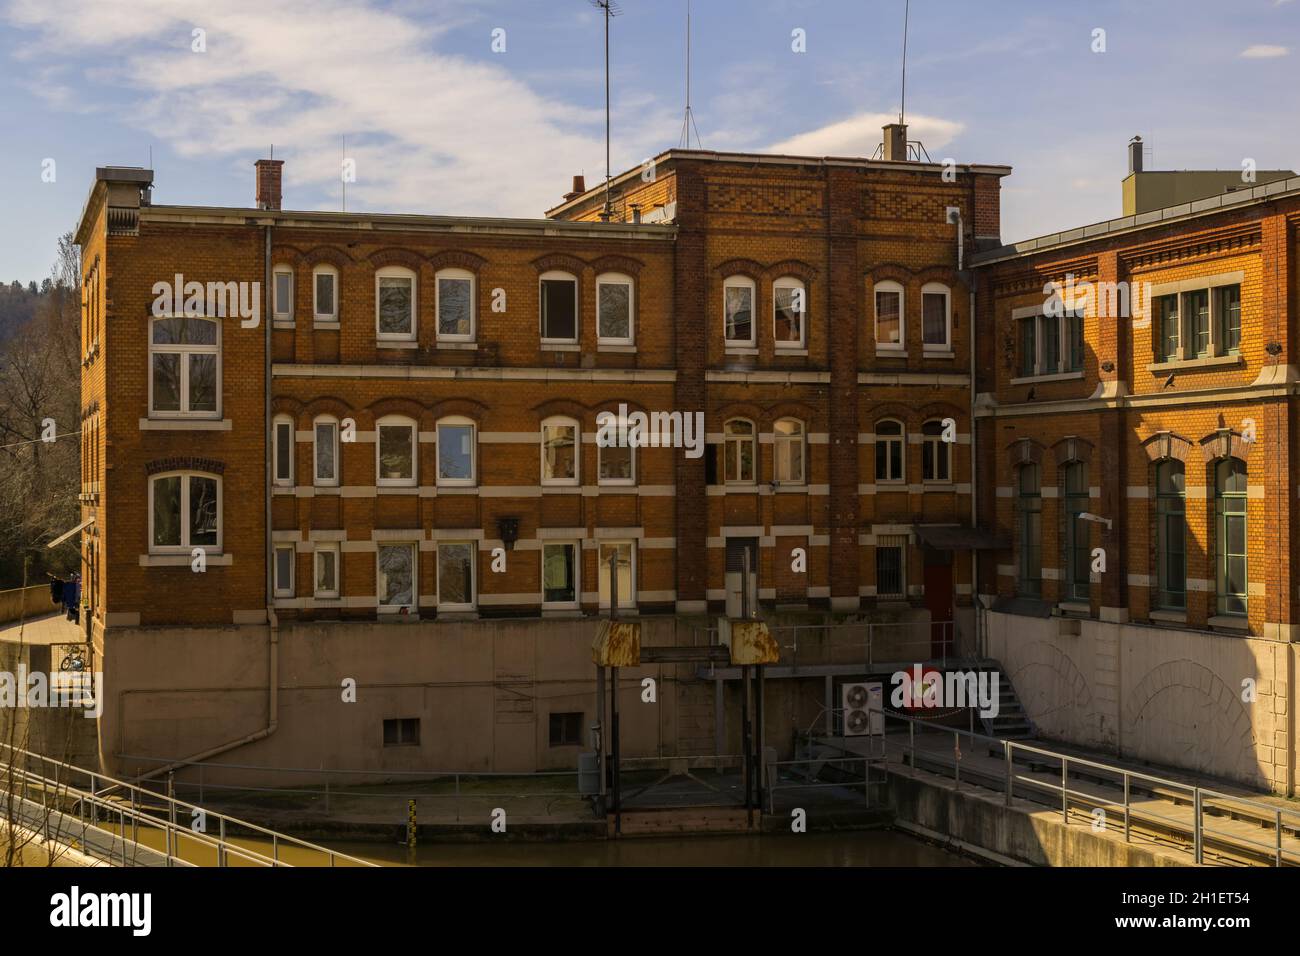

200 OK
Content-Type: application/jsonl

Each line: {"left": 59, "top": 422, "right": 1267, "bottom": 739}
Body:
{"left": 868, "top": 713, "right": 1300, "bottom": 866}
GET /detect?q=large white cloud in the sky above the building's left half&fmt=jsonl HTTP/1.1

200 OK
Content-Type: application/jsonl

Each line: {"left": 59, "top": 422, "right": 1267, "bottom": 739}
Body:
{"left": 7, "top": 0, "right": 673, "bottom": 216}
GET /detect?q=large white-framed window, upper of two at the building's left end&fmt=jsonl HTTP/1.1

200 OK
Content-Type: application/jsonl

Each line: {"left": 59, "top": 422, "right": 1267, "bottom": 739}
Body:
{"left": 150, "top": 315, "right": 221, "bottom": 419}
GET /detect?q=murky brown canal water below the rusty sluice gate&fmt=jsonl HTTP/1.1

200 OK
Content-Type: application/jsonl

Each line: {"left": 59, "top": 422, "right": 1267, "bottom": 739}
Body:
{"left": 329, "top": 830, "right": 978, "bottom": 866}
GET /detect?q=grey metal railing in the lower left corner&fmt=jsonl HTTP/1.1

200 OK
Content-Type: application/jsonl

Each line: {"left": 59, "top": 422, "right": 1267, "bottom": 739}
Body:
{"left": 0, "top": 744, "right": 376, "bottom": 866}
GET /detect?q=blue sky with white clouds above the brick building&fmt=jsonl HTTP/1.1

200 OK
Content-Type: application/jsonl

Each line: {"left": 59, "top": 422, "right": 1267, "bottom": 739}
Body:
{"left": 0, "top": 0, "right": 1300, "bottom": 282}
